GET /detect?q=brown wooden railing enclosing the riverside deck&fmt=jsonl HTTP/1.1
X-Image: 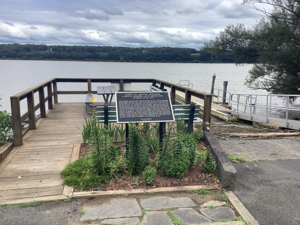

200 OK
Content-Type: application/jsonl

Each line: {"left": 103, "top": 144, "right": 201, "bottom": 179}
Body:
{"left": 10, "top": 78, "right": 212, "bottom": 146}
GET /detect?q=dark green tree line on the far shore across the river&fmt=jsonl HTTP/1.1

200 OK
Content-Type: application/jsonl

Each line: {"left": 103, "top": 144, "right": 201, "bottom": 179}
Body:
{"left": 0, "top": 44, "right": 235, "bottom": 63}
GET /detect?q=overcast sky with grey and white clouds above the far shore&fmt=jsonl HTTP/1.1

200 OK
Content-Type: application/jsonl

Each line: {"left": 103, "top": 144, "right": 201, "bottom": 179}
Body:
{"left": 0, "top": 0, "right": 259, "bottom": 49}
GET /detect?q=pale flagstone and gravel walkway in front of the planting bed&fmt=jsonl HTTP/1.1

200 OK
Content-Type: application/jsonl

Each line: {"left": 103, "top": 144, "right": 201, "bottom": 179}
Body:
{"left": 0, "top": 193, "right": 239, "bottom": 225}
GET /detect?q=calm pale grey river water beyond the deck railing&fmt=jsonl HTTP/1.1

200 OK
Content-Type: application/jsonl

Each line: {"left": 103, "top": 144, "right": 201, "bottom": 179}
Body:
{"left": 0, "top": 60, "right": 298, "bottom": 119}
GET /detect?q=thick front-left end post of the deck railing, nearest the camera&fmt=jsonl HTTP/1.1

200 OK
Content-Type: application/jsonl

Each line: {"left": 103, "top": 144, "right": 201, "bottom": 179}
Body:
{"left": 10, "top": 97, "right": 23, "bottom": 146}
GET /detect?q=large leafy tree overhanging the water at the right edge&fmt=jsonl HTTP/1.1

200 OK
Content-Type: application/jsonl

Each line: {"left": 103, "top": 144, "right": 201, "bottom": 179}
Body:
{"left": 203, "top": 0, "right": 300, "bottom": 94}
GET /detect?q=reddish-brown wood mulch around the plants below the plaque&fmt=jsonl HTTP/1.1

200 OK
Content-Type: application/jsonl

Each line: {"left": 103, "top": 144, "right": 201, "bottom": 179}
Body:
{"left": 75, "top": 143, "right": 221, "bottom": 191}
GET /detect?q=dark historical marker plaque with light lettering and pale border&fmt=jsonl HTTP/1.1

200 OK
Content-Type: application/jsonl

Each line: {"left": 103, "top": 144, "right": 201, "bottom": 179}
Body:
{"left": 116, "top": 92, "right": 174, "bottom": 123}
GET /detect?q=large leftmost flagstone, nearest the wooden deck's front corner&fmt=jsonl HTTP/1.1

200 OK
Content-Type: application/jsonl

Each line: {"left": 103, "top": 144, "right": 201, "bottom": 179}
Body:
{"left": 81, "top": 198, "right": 142, "bottom": 221}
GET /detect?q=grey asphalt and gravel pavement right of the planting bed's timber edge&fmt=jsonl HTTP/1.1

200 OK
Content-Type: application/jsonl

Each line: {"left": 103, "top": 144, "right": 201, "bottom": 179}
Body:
{"left": 220, "top": 137, "right": 300, "bottom": 225}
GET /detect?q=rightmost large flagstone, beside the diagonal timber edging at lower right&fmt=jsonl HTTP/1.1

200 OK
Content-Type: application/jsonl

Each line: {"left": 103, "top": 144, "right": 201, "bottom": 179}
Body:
{"left": 200, "top": 207, "right": 235, "bottom": 221}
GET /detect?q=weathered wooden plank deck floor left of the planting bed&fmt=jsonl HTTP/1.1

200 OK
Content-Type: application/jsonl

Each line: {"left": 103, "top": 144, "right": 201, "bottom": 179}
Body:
{"left": 0, "top": 103, "right": 89, "bottom": 204}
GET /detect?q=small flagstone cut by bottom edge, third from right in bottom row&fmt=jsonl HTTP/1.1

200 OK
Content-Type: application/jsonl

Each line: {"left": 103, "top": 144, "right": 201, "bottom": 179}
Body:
{"left": 141, "top": 211, "right": 173, "bottom": 225}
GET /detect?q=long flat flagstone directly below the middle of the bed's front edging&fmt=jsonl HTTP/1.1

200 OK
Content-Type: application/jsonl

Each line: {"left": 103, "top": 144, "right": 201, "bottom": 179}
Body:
{"left": 141, "top": 196, "right": 196, "bottom": 210}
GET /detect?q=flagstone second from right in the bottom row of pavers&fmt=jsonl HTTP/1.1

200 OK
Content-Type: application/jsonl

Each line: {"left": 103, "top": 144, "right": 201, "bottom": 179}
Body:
{"left": 173, "top": 208, "right": 211, "bottom": 224}
